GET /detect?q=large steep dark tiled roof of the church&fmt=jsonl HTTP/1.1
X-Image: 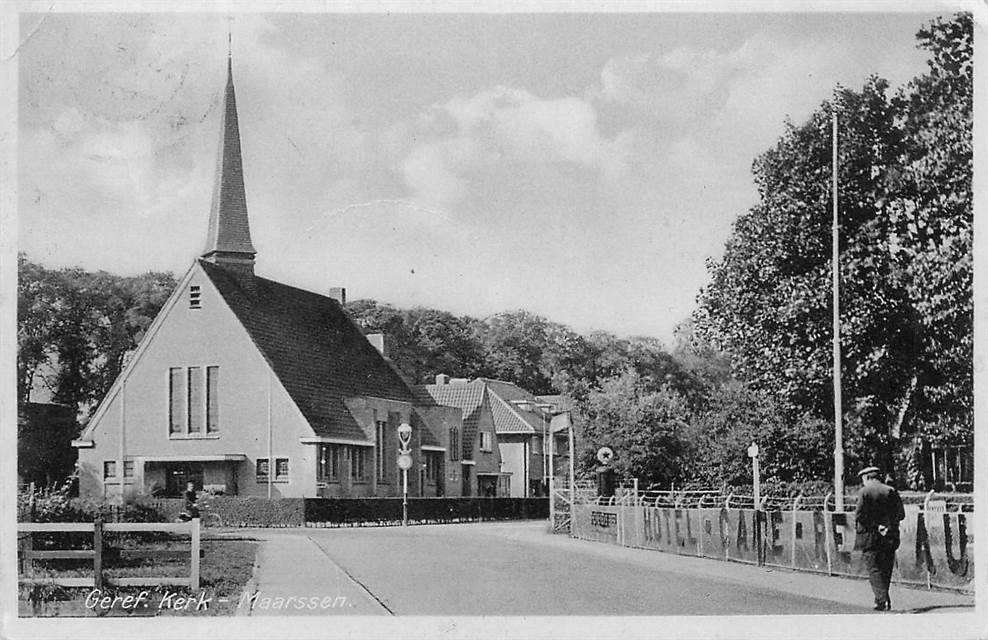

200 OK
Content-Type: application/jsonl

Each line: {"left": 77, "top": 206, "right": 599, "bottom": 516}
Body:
{"left": 199, "top": 260, "right": 414, "bottom": 439}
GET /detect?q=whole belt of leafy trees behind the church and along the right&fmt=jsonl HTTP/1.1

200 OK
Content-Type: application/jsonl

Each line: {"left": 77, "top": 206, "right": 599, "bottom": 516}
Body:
{"left": 17, "top": 14, "right": 974, "bottom": 488}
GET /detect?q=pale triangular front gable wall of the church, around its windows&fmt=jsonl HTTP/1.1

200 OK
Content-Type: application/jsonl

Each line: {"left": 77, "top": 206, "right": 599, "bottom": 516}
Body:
{"left": 79, "top": 263, "right": 316, "bottom": 497}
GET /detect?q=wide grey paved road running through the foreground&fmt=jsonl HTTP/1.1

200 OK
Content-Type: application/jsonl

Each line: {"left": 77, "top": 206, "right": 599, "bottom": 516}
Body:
{"left": 306, "top": 523, "right": 888, "bottom": 615}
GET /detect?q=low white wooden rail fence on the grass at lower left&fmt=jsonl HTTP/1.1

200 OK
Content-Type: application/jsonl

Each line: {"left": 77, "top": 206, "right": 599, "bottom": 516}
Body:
{"left": 17, "top": 518, "right": 202, "bottom": 591}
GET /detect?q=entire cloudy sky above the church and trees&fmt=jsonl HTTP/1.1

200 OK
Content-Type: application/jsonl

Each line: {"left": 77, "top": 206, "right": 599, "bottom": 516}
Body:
{"left": 16, "top": 3, "right": 947, "bottom": 343}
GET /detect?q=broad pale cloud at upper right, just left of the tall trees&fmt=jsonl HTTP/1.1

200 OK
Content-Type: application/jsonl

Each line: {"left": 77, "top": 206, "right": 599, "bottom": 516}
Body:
{"left": 588, "top": 28, "right": 865, "bottom": 156}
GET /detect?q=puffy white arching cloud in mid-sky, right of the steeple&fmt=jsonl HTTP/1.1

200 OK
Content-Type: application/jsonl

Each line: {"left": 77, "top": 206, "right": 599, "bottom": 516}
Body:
{"left": 402, "top": 86, "right": 630, "bottom": 204}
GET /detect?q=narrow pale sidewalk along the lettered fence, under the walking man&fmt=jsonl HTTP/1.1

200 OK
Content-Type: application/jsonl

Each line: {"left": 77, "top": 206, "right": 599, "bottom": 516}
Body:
{"left": 464, "top": 522, "right": 974, "bottom": 613}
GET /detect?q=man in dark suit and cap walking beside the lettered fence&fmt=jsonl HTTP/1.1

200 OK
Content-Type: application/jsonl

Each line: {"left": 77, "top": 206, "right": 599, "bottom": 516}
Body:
{"left": 854, "top": 467, "right": 906, "bottom": 611}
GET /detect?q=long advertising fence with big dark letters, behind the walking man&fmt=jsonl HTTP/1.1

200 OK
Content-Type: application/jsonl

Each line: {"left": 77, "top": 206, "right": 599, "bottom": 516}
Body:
{"left": 572, "top": 504, "right": 974, "bottom": 591}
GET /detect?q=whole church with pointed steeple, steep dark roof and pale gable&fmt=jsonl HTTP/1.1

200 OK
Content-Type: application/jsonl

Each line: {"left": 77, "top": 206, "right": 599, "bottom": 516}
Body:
{"left": 72, "top": 58, "right": 458, "bottom": 498}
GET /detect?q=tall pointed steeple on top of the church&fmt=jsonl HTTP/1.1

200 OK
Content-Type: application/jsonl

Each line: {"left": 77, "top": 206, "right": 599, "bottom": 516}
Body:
{"left": 202, "top": 56, "right": 257, "bottom": 274}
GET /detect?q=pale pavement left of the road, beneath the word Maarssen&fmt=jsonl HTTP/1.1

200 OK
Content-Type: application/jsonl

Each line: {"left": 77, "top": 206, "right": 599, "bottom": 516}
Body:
{"left": 237, "top": 529, "right": 391, "bottom": 616}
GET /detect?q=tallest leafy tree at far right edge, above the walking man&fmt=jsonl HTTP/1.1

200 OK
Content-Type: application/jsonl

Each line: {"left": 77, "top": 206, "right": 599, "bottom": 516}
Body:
{"left": 890, "top": 13, "right": 974, "bottom": 486}
